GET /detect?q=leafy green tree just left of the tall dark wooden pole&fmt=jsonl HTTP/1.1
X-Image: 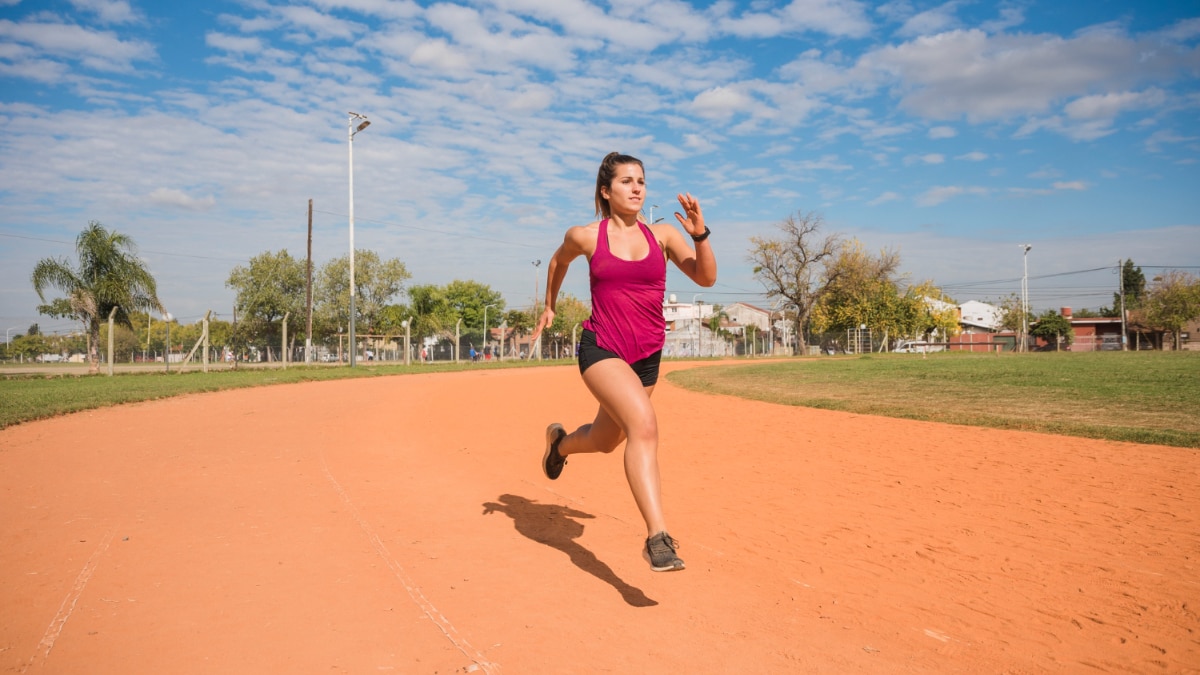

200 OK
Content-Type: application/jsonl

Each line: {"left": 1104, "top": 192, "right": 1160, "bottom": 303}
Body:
{"left": 226, "top": 249, "right": 306, "bottom": 346}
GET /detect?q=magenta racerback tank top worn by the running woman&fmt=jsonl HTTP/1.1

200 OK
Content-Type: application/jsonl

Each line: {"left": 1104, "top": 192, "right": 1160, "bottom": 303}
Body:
{"left": 583, "top": 219, "right": 667, "bottom": 364}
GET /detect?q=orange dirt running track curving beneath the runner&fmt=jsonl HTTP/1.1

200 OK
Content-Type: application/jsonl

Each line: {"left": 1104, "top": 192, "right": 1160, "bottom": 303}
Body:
{"left": 0, "top": 365, "right": 1200, "bottom": 674}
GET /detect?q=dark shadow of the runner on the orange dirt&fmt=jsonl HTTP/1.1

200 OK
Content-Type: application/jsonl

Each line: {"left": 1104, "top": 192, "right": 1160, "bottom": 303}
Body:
{"left": 484, "top": 495, "right": 659, "bottom": 607}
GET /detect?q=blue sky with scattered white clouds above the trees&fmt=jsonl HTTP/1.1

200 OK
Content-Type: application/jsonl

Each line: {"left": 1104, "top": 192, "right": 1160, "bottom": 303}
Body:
{"left": 0, "top": 0, "right": 1200, "bottom": 331}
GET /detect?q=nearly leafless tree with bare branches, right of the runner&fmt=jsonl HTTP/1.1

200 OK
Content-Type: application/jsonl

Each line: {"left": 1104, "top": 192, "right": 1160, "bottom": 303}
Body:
{"left": 748, "top": 211, "right": 840, "bottom": 350}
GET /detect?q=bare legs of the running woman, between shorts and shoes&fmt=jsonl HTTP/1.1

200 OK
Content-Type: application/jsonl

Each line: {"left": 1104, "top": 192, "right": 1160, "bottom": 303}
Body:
{"left": 558, "top": 359, "right": 666, "bottom": 537}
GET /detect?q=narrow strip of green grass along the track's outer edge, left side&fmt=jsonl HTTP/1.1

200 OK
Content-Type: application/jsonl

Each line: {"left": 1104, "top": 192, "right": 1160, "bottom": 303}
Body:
{"left": 0, "top": 362, "right": 557, "bottom": 429}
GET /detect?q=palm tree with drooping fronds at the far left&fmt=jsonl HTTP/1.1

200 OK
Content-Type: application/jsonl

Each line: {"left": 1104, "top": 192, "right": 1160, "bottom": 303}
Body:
{"left": 30, "top": 221, "right": 162, "bottom": 374}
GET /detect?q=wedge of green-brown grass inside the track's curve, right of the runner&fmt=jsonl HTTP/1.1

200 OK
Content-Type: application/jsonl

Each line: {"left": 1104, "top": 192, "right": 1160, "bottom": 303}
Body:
{"left": 668, "top": 352, "right": 1200, "bottom": 448}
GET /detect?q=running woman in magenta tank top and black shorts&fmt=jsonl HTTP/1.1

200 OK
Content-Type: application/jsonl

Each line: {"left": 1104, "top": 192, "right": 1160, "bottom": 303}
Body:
{"left": 532, "top": 153, "right": 716, "bottom": 572}
